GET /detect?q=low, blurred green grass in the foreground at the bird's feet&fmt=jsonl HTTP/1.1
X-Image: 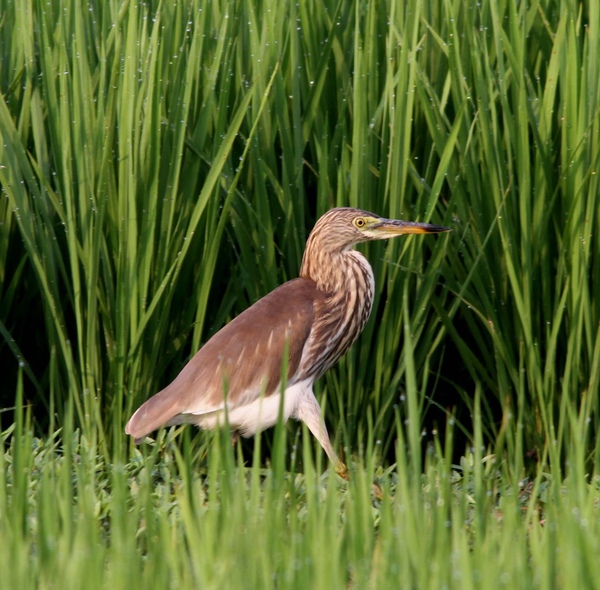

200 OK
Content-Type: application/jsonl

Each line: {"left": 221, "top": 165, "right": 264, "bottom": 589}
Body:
{"left": 0, "top": 384, "right": 600, "bottom": 588}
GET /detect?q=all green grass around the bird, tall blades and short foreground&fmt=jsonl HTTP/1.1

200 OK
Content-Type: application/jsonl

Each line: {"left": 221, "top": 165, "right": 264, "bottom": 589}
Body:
{"left": 0, "top": 0, "right": 600, "bottom": 588}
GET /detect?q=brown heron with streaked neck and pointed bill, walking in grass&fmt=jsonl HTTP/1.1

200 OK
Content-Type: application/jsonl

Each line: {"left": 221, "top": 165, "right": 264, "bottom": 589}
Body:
{"left": 125, "top": 207, "right": 450, "bottom": 479}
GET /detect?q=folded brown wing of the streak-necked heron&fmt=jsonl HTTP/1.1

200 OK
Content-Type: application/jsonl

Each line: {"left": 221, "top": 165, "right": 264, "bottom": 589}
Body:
{"left": 125, "top": 278, "right": 324, "bottom": 439}
